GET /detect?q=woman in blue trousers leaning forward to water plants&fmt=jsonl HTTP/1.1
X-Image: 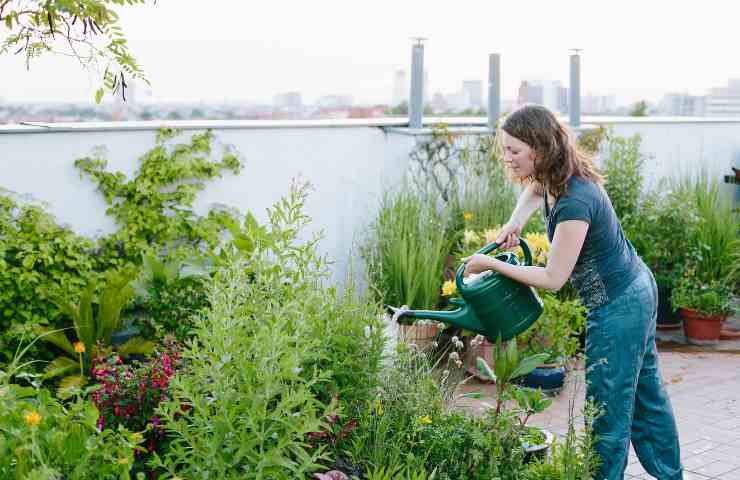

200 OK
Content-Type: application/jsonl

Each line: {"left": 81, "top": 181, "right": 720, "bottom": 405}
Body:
{"left": 465, "top": 105, "right": 682, "bottom": 480}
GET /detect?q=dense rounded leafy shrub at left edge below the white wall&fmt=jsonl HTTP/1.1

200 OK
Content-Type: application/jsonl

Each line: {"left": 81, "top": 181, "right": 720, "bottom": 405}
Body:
{"left": 0, "top": 195, "right": 95, "bottom": 362}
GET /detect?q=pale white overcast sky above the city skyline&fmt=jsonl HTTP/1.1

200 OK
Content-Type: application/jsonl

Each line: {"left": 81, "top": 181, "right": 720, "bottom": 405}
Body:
{"left": 0, "top": 0, "right": 740, "bottom": 103}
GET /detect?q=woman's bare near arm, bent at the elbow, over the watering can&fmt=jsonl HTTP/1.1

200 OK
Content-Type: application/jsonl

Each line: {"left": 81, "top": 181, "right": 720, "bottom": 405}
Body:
{"left": 465, "top": 220, "right": 589, "bottom": 291}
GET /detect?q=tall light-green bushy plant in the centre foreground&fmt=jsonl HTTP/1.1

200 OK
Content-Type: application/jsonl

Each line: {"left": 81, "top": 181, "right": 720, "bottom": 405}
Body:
{"left": 156, "top": 185, "right": 380, "bottom": 480}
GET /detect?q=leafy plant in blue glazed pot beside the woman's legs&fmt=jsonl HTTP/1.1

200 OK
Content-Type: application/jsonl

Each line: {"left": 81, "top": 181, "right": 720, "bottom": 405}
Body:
{"left": 518, "top": 294, "right": 586, "bottom": 393}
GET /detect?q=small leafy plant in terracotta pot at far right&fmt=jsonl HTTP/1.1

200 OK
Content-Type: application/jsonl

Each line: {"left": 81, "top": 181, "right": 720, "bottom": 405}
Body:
{"left": 673, "top": 270, "right": 732, "bottom": 345}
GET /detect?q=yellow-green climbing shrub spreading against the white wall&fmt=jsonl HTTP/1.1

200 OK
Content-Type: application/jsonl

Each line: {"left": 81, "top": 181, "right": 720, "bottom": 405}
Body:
{"left": 75, "top": 128, "right": 241, "bottom": 265}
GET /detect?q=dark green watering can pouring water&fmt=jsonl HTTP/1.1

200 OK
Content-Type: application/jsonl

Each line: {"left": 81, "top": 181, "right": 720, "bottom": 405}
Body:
{"left": 387, "top": 238, "right": 543, "bottom": 342}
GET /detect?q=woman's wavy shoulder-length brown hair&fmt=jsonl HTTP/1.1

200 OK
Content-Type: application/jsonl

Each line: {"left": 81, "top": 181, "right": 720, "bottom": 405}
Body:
{"left": 497, "top": 105, "right": 604, "bottom": 198}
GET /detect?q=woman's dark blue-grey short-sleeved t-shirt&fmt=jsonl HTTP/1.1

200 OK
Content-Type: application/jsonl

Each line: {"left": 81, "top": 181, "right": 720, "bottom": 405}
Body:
{"left": 545, "top": 176, "right": 642, "bottom": 308}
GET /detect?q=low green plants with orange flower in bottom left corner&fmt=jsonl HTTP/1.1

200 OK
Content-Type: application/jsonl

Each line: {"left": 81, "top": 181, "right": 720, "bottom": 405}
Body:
{"left": 0, "top": 337, "right": 142, "bottom": 480}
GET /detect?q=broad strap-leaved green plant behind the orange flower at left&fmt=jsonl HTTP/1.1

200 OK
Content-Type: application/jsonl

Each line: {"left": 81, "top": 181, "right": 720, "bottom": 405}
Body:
{"left": 37, "top": 268, "right": 153, "bottom": 395}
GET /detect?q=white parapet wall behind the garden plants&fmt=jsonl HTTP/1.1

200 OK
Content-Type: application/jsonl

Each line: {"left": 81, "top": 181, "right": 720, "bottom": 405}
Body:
{"left": 0, "top": 117, "right": 740, "bottom": 284}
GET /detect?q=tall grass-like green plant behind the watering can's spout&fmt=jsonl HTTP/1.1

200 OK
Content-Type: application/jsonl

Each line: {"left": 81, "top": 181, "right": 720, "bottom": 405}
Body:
{"left": 363, "top": 189, "right": 452, "bottom": 309}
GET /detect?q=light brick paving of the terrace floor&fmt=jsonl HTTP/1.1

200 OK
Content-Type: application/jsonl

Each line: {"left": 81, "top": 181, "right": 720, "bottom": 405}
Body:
{"left": 460, "top": 344, "right": 740, "bottom": 480}
